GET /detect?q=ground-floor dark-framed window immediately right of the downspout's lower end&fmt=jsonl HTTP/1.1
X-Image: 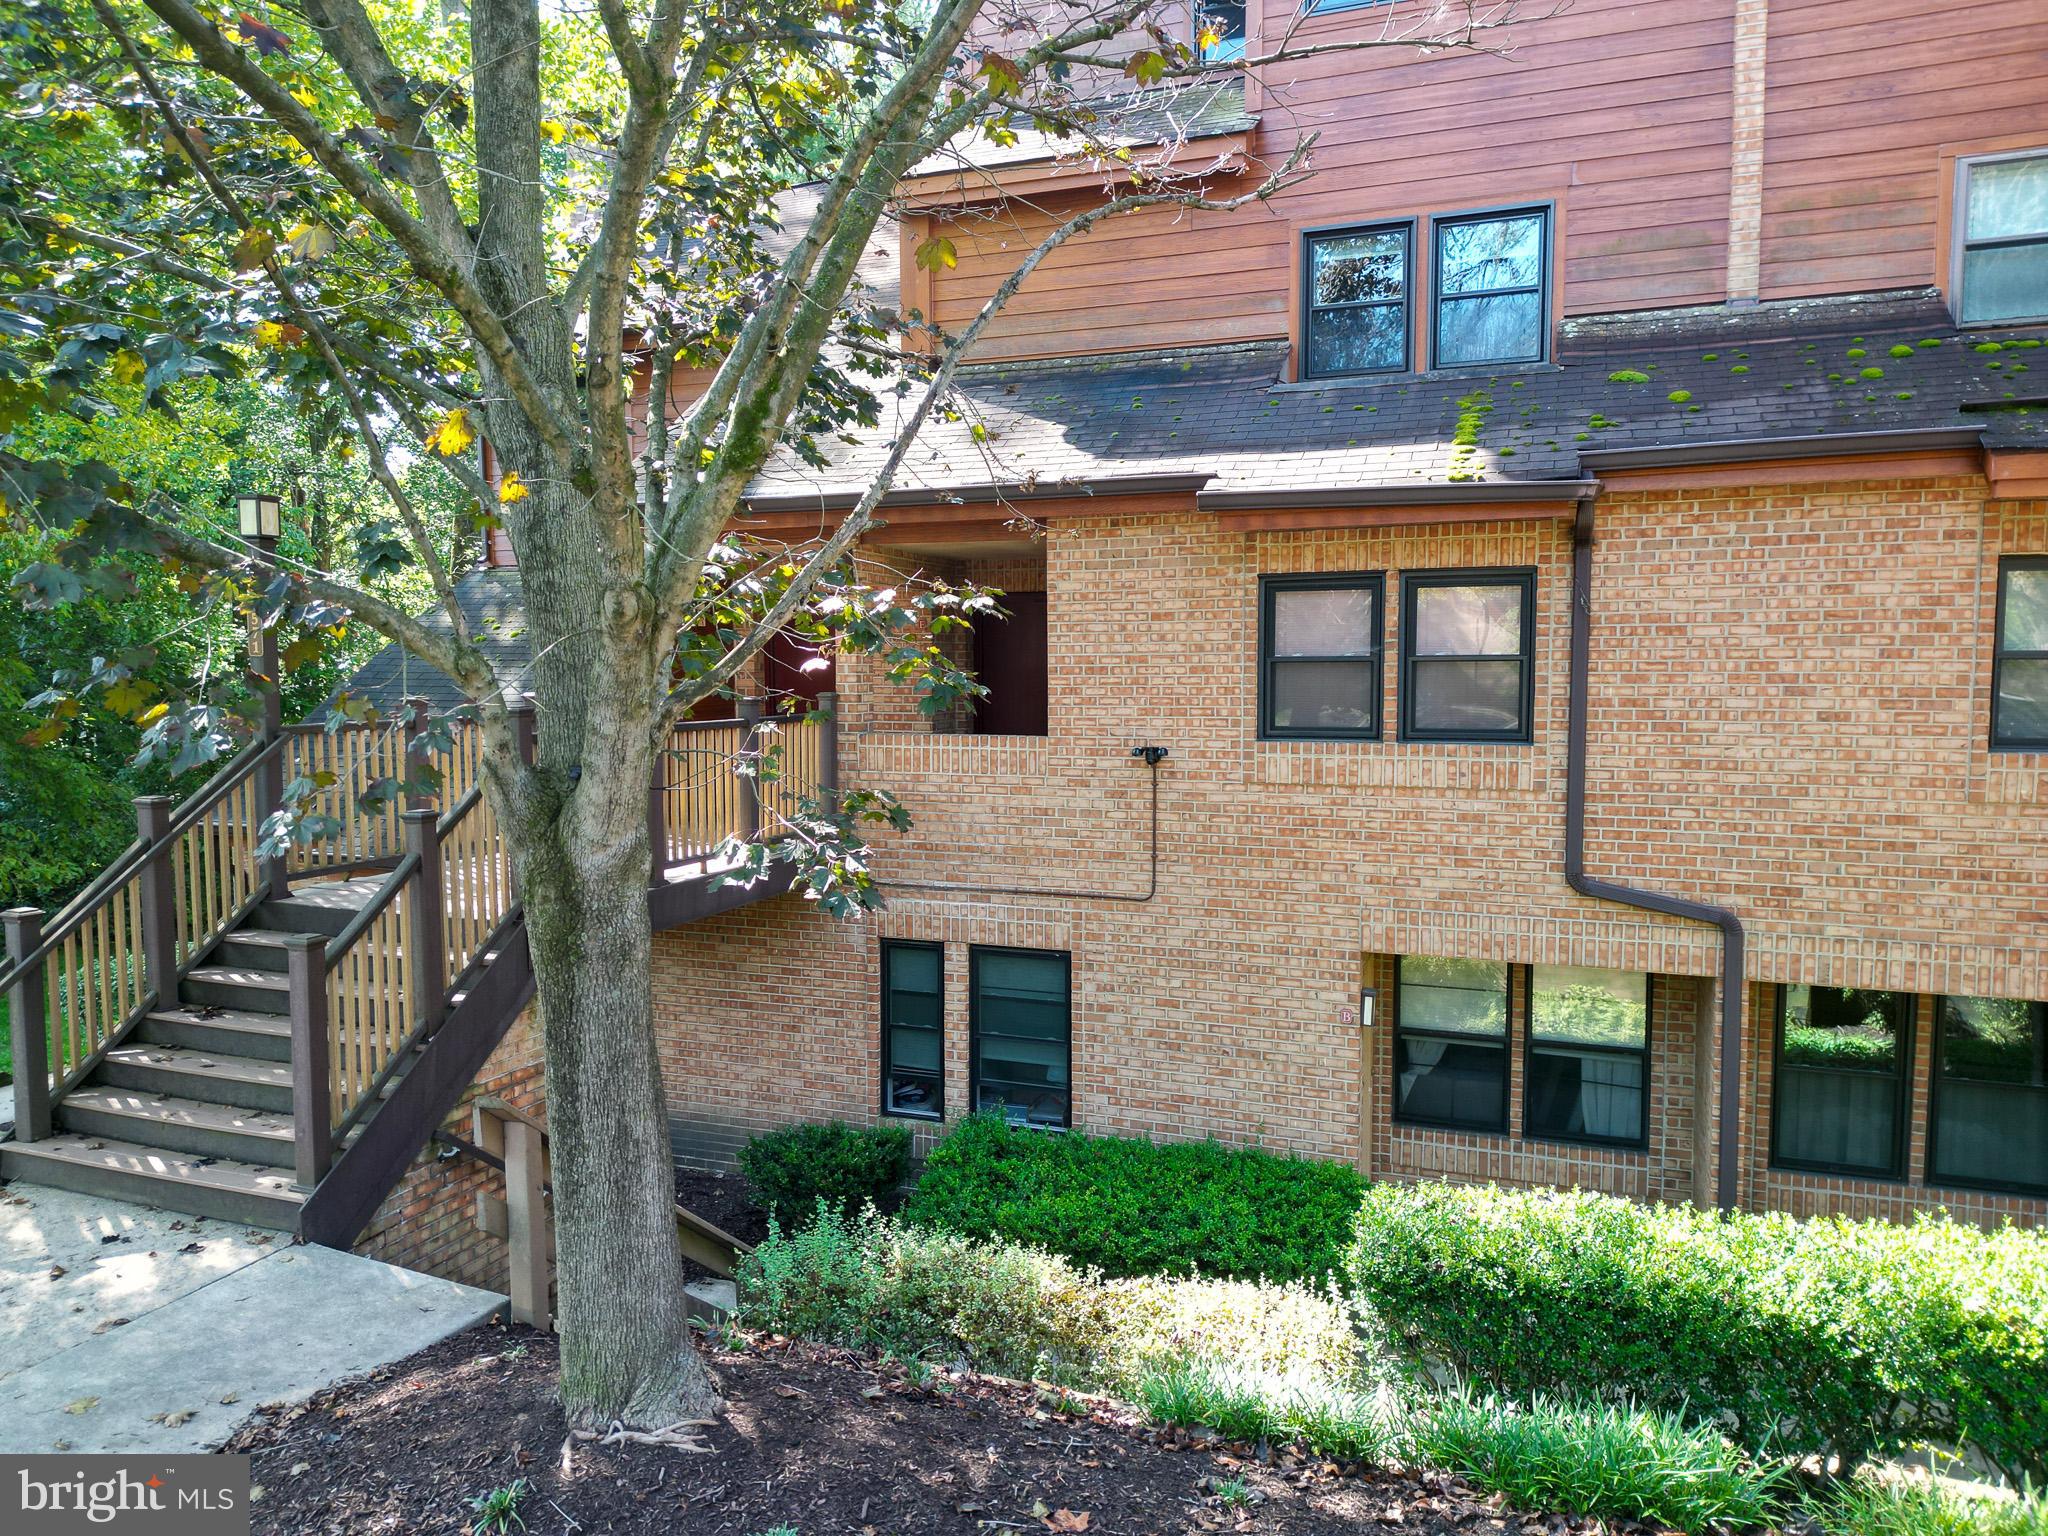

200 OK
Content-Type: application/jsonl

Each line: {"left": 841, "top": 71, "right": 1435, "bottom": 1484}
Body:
{"left": 1772, "top": 985, "right": 1913, "bottom": 1178}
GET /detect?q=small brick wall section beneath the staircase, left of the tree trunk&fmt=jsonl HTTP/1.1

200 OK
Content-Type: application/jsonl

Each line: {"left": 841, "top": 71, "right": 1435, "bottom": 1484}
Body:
{"left": 356, "top": 1008, "right": 547, "bottom": 1290}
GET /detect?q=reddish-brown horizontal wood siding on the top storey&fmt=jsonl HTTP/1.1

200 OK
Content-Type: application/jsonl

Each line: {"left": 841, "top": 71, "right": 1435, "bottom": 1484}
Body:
{"left": 920, "top": 0, "right": 2048, "bottom": 360}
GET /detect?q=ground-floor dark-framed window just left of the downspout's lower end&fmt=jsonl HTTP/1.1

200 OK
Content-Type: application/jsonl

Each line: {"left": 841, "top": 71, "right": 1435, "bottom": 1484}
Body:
{"left": 1522, "top": 965, "right": 1651, "bottom": 1147}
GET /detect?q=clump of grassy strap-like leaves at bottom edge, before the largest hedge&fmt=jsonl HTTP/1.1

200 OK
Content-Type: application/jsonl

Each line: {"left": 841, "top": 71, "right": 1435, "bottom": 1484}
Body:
{"left": 1409, "top": 1395, "right": 1786, "bottom": 1532}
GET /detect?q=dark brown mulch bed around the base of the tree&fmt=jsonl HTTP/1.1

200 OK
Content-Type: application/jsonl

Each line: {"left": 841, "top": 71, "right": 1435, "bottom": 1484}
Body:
{"left": 227, "top": 1325, "right": 1612, "bottom": 1536}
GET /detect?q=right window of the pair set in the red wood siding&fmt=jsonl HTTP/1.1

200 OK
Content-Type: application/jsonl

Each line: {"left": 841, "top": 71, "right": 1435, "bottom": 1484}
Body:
{"left": 1432, "top": 209, "right": 1550, "bottom": 369}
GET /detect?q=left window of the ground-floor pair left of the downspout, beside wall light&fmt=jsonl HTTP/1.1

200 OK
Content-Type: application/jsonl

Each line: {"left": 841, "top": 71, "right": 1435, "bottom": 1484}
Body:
{"left": 1395, "top": 954, "right": 1509, "bottom": 1130}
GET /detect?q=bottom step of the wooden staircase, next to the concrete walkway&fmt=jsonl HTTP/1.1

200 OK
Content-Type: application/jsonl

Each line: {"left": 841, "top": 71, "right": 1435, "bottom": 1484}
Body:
{"left": 0, "top": 1135, "right": 305, "bottom": 1231}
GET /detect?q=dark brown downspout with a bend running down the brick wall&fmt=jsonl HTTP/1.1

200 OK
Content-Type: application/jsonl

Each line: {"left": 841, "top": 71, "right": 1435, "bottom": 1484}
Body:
{"left": 1565, "top": 496, "right": 1743, "bottom": 1210}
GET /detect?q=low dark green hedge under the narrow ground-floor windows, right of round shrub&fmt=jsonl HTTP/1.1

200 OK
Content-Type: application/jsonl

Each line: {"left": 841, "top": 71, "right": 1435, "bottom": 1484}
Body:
{"left": 903, "top": 1116, "right": 1364, "bottom": 1282}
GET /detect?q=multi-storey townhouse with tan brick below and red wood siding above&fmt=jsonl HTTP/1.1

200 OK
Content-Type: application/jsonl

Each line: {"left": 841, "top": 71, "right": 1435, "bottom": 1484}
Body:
{"left": 380, "top": 0, "right": 2048, "bottom": 1223}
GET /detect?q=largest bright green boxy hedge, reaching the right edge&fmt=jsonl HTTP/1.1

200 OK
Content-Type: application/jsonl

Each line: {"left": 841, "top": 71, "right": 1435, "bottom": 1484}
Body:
{"left": 1350, "top": 1186, "right": 2048, "bottom": 1477}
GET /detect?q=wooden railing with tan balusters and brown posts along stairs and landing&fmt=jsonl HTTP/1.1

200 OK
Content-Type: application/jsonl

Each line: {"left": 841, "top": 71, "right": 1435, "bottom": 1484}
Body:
{"left": 0, "top": 694, "right": 838, "bottom": 1188}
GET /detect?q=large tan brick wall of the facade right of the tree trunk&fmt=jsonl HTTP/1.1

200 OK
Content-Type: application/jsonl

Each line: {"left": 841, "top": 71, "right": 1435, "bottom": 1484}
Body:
{"left": 655, "top": 479, "right": 2048, "bottom": 1221}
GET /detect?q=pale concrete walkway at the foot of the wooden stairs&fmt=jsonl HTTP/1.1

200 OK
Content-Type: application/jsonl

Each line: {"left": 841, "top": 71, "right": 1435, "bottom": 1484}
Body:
{"left": 0, "top": 1184, "right": 504, "bottom": 1454}
